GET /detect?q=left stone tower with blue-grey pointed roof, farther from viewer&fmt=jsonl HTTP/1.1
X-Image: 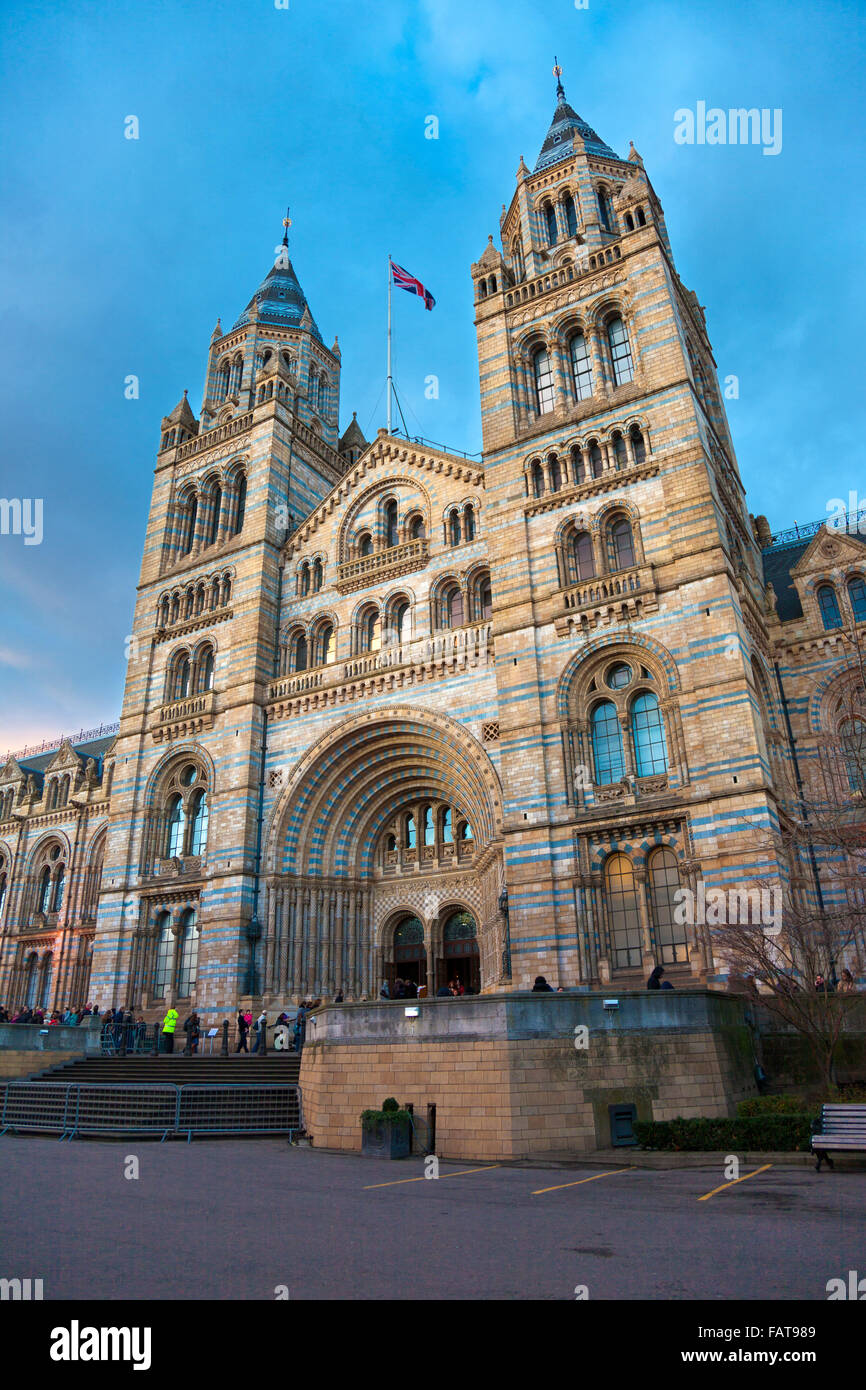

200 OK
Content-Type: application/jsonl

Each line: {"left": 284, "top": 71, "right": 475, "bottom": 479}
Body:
{"left": 93, "top": 218, "right": 343, "bottom": 1009}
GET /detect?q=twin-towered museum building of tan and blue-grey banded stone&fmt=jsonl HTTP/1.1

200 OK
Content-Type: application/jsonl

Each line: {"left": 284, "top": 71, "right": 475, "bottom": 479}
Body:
{"left": 0, "top": 86, "right": 866, "bottom": 1016}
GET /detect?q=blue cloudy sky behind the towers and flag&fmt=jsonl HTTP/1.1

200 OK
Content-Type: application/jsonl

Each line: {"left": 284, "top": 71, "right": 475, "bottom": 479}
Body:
{"left": 0, "top": 0, "right": 866, "bottom": 752}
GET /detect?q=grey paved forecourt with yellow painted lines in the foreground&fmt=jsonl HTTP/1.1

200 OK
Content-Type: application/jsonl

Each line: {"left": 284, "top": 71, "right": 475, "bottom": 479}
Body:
{"left": 0, "top": 1136, "right": 866, "bottom": 1300}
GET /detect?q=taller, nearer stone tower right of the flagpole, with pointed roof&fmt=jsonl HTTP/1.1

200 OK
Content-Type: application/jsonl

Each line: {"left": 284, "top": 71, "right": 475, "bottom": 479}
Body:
{"left": 471, "top": 68, "right": 774, "bottom": 984}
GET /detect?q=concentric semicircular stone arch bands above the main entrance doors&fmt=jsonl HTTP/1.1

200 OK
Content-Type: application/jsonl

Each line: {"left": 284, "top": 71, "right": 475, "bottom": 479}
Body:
{"left": 267, "top": 706, "right": 502, "bottom": 878}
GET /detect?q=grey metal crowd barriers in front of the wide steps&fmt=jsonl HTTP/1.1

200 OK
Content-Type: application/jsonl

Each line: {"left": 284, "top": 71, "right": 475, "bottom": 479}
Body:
{"left": 0, "top": 1081, "right": 303, "bottom": 1143}
